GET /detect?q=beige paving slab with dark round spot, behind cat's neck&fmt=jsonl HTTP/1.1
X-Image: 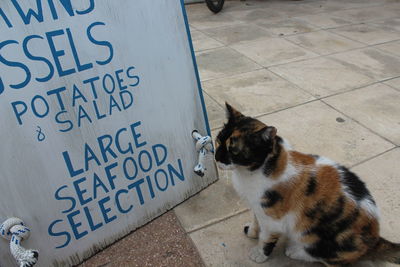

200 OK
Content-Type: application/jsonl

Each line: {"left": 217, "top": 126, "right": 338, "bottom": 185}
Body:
{"left": 259, "top": 101, "right": 394, "bottom": 166}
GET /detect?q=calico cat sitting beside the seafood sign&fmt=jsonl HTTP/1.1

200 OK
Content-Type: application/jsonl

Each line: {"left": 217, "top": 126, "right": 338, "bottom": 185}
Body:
{"left": 215, "top": 104, "right": 400, "bottom": 267}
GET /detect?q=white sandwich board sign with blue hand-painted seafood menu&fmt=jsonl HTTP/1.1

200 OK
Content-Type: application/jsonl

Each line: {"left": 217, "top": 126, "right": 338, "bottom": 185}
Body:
{"left": 0, "top": 0, "right": 217, "bottom": 266}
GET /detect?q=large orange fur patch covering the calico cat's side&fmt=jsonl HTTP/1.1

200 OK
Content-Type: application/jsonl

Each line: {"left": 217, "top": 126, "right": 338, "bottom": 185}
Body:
{"left": 264, "top": 156, "right": 379, "bottom": 263}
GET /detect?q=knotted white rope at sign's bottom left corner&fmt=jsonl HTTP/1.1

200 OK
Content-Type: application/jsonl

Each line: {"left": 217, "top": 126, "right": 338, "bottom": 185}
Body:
{"left": 0, "top": 218, "right": 39, "bottom": 267}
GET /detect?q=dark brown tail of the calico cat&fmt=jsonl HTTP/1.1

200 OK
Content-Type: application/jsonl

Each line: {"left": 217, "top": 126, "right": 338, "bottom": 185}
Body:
{"left": 363, "top": 237, "right": 400, "bottom": 264}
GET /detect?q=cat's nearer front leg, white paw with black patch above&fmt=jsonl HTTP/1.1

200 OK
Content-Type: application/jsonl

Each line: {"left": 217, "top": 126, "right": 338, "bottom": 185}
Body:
{"left": 249, "top": 233, "right": 280, "bottom": 263}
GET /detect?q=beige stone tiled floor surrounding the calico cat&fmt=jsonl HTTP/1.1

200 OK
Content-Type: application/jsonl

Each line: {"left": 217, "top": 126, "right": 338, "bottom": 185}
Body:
{"left": 81, "top": 0, "right": 400, "bottom": 267}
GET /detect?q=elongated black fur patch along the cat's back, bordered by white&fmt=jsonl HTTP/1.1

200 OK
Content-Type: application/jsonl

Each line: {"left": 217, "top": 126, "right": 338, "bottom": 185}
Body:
{"left": 339, "top": 166, "right": 375, "bottom": 204}
